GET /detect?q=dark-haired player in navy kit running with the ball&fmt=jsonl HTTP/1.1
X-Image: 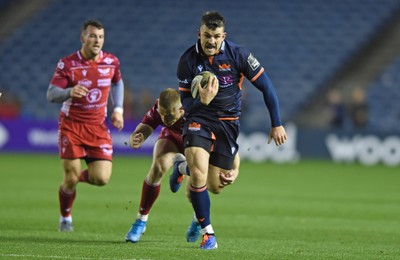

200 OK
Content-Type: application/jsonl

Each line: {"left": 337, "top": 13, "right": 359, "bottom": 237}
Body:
{"left": 173, "top": 12, "right": 287, "bottom": 249}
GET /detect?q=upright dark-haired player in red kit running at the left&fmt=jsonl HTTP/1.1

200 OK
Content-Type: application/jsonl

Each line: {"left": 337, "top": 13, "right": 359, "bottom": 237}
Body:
{"left": 47, "top": 20, "right": 124, "bottom": 232}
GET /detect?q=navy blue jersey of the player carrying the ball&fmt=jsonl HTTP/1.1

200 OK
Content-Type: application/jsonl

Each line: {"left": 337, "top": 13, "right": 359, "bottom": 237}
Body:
{"left": 177, "top": 40, "right": 264, "bottom": 120}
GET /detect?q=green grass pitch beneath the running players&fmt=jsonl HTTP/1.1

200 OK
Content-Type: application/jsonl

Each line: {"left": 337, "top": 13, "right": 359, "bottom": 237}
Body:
{"left": 0, "top": 154, "right": 400, "bottom": 260}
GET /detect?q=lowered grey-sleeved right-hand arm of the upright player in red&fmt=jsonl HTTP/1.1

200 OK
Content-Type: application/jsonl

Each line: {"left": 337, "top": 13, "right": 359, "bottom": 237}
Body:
{"left": 111, "top": 79, "right": 124, "bottom": 130}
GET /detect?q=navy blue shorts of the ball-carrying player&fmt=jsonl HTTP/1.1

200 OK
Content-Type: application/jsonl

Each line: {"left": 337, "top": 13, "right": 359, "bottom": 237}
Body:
{"left": 183, "top": 118, "right": 239, "bottom": 170}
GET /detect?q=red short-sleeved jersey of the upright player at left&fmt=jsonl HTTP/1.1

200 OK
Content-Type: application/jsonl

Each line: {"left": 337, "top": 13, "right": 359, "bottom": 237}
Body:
{"left": 50, "top": 51, "right": 122, "bottom": 124}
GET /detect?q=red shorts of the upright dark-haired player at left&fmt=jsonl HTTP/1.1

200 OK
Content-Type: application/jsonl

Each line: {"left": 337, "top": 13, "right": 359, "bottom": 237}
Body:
{"left": 58, "top": 116, "right": 113, "bottom": 161}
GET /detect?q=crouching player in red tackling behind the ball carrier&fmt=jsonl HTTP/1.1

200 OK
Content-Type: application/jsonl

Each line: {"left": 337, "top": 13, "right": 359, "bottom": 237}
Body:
{"left": 125, "top": 88, "right": 239, "bottom": 243}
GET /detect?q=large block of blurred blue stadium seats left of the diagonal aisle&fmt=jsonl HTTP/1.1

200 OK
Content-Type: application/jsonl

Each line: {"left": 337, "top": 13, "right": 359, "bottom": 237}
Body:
{"left": 0, "top": 0, "right": 400, "bottom": 129}
